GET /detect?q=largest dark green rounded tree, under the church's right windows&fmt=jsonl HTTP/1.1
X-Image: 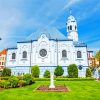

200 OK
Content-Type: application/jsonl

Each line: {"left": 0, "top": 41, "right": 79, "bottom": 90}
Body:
{"left": 67, "top": 64, "right": 78, "bottom": 78}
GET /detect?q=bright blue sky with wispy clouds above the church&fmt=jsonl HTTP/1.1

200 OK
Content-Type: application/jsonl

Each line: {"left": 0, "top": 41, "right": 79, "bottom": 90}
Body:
{"left": 0, "top": 0, "right": 100, "bottom": 51}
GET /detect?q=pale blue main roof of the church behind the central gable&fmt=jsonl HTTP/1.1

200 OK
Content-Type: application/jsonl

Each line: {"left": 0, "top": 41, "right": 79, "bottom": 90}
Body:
{"left": 26, "top": 28, "right": 67, "bottom": 40}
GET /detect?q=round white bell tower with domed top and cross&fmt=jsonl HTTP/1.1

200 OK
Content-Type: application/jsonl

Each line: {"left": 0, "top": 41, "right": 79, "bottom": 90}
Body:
{"left": 66, "top": 11, "right": 78, "bottom": 41}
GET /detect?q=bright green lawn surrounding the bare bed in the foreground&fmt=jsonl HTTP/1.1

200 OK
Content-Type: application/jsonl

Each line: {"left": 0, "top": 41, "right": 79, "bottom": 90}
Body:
{"left": 0, "top": 81, "right": 100, "bottom": 100}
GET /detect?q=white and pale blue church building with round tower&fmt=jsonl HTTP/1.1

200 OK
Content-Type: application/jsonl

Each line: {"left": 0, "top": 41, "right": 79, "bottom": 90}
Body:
{"left": 6, "top": 15, "right": 88, "bottom": 77}
